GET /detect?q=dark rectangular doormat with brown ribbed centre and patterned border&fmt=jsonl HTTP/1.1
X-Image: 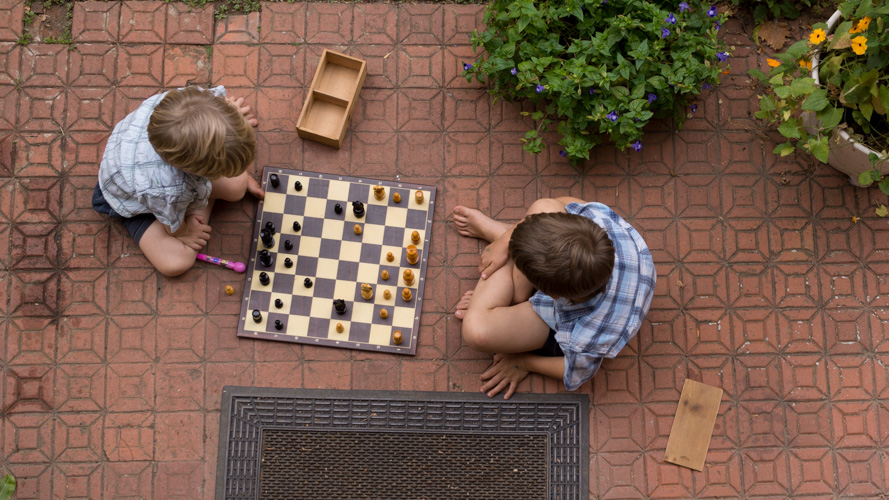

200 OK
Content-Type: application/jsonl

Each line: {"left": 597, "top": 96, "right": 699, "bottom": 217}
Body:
{"left": 216, "top": 386, "right": 589, "bottom": 500}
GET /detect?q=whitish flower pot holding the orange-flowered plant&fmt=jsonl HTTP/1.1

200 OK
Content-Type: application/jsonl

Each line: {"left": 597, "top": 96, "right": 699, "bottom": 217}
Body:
{"left": 803, "top": 11, "right": 889, "bottom": 186}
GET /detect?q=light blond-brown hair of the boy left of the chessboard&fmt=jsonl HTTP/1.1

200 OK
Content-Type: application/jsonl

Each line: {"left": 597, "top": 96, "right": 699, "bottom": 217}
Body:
{"left": 148, "top": 87, "right": 256, "bottom": 180}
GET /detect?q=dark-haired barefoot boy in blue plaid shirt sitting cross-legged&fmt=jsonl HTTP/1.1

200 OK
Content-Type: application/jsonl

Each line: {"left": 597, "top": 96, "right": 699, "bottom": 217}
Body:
{"left": 454, "top": 197, "right": 657, "bottom": 399}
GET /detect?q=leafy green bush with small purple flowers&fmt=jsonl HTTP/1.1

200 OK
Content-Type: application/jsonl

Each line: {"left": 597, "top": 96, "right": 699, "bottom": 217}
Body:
{"left": 463, "top": 0, "right": 728, "bottom": 162}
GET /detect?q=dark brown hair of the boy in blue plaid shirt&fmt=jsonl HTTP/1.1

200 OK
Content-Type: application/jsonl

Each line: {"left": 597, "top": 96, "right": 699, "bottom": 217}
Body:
{"left": 509, "top": 213, "right": 614, "bottom": 300}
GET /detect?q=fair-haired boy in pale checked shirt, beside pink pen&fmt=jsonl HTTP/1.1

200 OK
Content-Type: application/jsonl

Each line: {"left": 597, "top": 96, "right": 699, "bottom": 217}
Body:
{"left": 92, "top": 86, "right": 264, "bottom": 276}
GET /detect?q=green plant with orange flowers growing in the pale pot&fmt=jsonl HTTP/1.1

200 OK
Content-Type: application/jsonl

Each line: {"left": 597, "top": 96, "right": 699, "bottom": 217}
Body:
{"left": 749, "top": 0, "right": 889, "bottom": 164}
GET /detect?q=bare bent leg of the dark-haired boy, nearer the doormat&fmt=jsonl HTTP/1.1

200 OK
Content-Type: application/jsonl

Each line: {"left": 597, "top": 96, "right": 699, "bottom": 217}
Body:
{"left": 463, "top": 265, "right": 549, "bottom": 353}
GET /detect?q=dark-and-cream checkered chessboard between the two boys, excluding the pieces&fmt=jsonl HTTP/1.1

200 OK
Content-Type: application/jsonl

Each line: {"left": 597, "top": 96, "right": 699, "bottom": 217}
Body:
{"left": 238, "top": 167, "right": 435, "bottom": 355}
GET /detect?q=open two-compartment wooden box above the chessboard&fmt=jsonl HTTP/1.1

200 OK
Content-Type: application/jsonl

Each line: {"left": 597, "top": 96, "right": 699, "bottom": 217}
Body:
{"left": 296, "top": 49, "right": 367, "bottom": 149}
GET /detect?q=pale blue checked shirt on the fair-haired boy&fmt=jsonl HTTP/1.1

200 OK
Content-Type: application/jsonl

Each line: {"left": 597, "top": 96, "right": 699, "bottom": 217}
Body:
{"left": 99, "top": 85, "right": 225, "bottom": 232}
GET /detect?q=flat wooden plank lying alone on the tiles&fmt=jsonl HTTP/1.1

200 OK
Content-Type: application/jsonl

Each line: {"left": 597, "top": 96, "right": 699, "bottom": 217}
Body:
{"left": 664, "top": 379, "right": 722, "bottom": 471}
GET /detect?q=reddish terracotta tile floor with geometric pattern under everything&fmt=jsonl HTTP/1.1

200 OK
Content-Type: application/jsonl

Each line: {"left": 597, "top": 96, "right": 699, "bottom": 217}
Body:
{"left": 0, "top": 0, "right": 889, "bottom": 499}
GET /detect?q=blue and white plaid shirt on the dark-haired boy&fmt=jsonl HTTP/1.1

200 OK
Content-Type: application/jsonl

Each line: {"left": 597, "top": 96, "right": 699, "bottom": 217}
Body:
{"left": 531, "top": 203, "right": 657, "bottom": 391}
